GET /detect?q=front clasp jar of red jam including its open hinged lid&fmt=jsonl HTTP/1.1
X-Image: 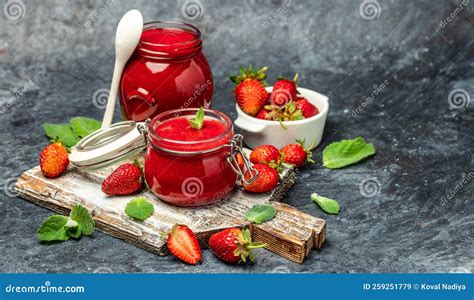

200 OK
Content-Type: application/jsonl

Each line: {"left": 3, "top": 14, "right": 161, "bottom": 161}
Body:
{"left": 69, "top": 108, "right": 258, "bottom": 206}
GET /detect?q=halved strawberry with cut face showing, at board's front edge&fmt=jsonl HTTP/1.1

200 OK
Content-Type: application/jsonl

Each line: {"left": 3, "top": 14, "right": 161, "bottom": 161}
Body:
{"left": 166, "top": 224, "right": 202, "bottom": 265}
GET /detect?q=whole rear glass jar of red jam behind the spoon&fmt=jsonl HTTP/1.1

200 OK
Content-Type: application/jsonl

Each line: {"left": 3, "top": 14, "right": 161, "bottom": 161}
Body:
{"left": 119, "top": 21, "right": 213, "bottom": 121}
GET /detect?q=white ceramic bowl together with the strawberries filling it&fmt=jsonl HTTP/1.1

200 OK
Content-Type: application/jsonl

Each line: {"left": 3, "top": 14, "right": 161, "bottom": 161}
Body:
{"left": 230, "top": 67, "right": 329, "bottom": 149}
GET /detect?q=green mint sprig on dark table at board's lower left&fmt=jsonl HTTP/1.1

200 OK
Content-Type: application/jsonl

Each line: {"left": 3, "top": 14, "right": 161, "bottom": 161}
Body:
{"left": 36, "top": 204, "right": 95, "bottom": 242}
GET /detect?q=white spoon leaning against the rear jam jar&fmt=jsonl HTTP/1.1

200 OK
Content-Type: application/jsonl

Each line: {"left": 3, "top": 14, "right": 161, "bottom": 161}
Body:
{"left": 102, "top": 9, "right": 143, "bottom": 128}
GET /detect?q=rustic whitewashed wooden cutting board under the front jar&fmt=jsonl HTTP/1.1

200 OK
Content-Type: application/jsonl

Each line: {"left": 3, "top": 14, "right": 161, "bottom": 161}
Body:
{"left": 16, "top": 156, "right": 326, "bottom": 263}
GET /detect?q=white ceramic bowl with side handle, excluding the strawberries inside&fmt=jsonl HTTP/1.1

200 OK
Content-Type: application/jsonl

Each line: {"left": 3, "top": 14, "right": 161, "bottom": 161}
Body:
{"left": 234, "top": 87, "right": 329, "bottom": 149}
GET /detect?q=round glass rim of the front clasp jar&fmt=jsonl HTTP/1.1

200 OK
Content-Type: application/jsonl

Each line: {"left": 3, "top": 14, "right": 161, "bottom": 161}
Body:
{"left": 148, "top": 108, "right": 233, "bottom": 153}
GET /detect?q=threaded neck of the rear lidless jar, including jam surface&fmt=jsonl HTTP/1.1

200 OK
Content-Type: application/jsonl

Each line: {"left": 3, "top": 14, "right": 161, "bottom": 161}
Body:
{"left": 135, "top": 21, "right": 202, "bottom": 60}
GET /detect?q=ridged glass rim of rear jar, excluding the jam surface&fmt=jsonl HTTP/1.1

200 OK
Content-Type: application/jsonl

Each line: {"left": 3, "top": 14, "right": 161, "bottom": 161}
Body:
{"left": 137, "top": 21, "right": 202, "bottom": 57}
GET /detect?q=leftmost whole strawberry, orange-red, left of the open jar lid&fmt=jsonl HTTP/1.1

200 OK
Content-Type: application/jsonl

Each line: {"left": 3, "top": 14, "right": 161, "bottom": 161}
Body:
{"left": 40, "top": 143, "right": 69, "bottom": 178}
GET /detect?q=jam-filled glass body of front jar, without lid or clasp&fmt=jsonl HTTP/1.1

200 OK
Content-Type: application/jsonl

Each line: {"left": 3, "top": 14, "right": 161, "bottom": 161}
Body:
{"left": 145, "top": 109, "right": 237, "bottom": 206}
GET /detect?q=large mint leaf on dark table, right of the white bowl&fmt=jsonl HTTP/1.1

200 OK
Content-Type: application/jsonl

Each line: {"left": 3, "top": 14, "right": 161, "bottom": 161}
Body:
{"left": 323, "top": 137, "right": 375, "bottom": 169}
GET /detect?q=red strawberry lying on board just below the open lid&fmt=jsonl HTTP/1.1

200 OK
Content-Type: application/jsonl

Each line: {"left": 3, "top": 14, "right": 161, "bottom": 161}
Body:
{"left": 102, "top": 163, "right": 142, "bottom": 196}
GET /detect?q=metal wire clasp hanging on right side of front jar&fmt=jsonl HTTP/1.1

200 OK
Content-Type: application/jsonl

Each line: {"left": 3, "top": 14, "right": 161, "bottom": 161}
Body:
{"left": 226, "top": 134, "right": 258, "bottom": 184}
